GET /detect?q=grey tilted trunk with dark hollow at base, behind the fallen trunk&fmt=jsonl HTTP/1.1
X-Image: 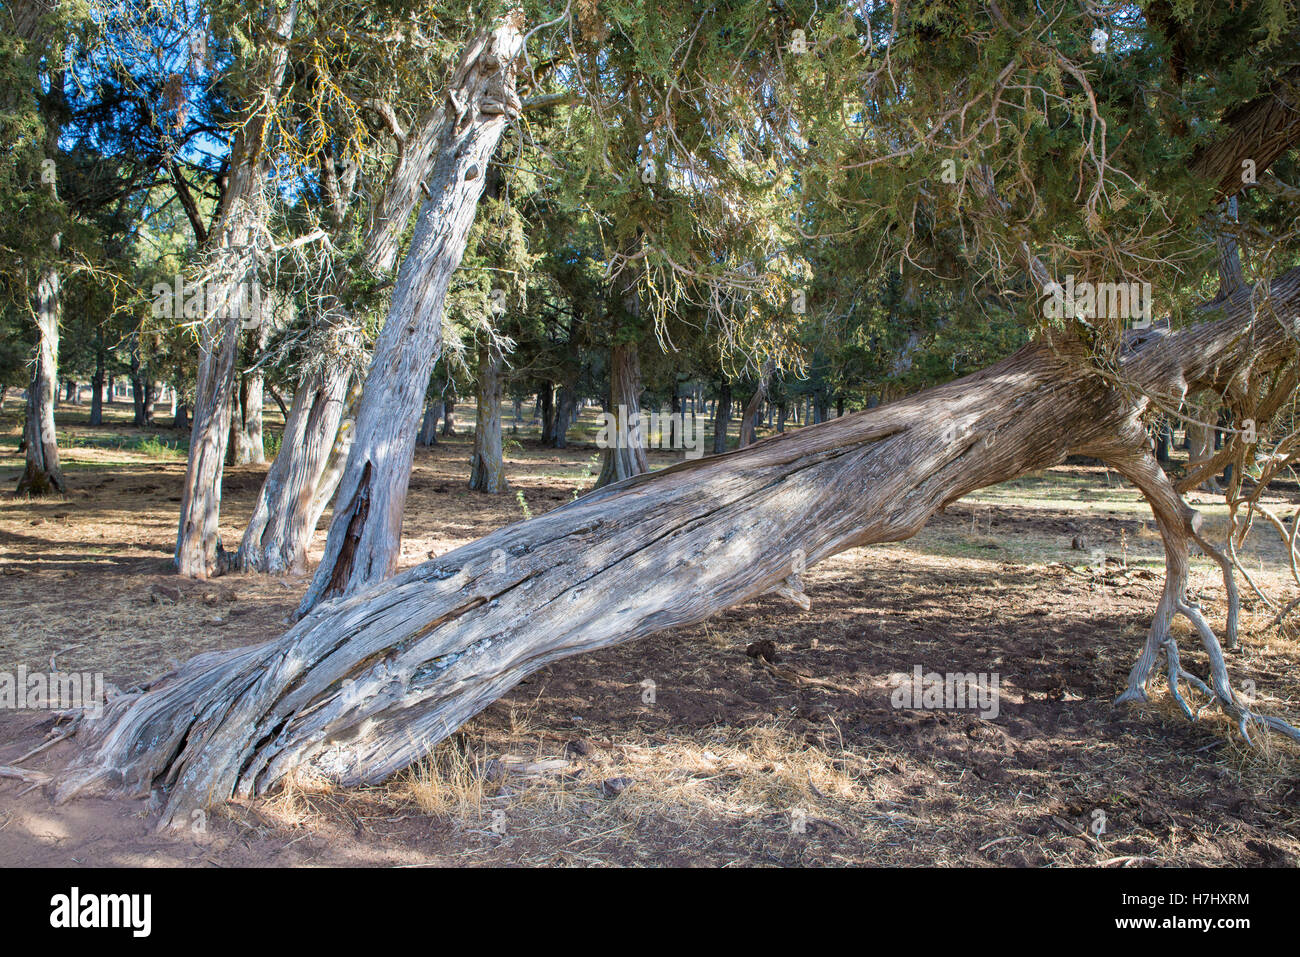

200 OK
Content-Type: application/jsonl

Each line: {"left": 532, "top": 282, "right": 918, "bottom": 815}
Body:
{"left": 298, "top": 13, "right": 523, "bottom": 615}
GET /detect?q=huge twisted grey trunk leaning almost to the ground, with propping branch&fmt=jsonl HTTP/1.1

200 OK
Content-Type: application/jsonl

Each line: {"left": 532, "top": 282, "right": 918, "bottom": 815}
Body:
{"left": 57, "top": 269, "right": 1300, "bottom": 824}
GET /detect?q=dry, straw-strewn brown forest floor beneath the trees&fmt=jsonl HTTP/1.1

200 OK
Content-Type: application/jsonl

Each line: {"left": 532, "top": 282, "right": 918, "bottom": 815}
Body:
{"left": 0, "top": 399, "right": 1300, "bottom": 867}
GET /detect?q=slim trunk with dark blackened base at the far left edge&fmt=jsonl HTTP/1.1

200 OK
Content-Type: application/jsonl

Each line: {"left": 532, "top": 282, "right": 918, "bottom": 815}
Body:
{"left": 18, "top": 267, "right": 68, "bottom": 495}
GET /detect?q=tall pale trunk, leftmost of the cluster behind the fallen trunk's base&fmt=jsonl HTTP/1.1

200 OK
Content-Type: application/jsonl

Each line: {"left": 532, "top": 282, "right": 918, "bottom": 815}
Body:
{"left": 176, "top": 0, "right": 298, "bottom": 579}
